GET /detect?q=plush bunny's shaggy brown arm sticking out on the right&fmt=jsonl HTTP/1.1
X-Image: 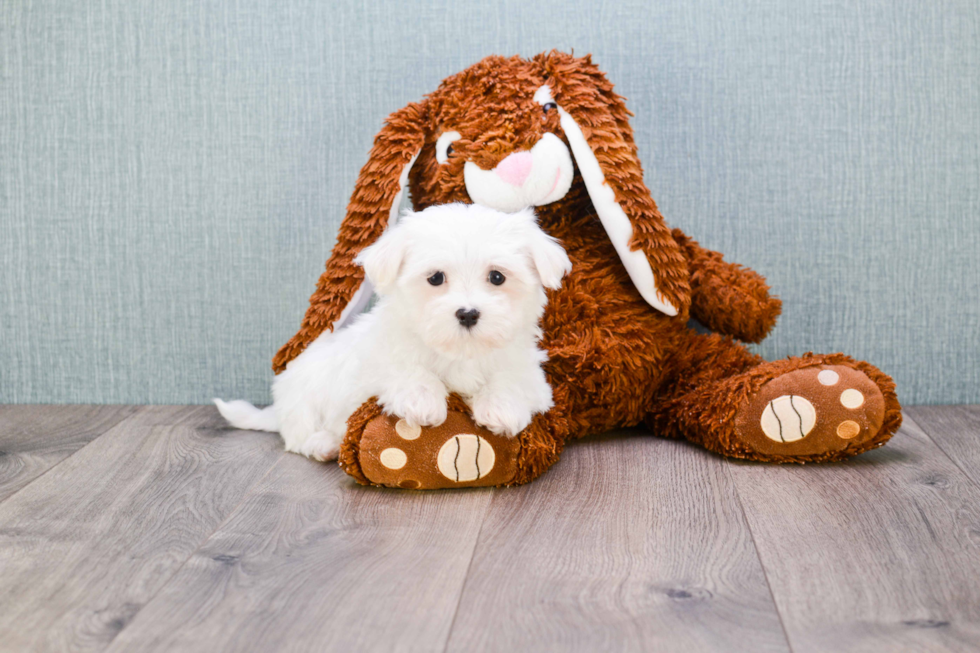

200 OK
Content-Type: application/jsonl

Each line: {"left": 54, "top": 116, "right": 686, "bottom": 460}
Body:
{"left": 673, "top": 229, "right": 783, "bottom": 342}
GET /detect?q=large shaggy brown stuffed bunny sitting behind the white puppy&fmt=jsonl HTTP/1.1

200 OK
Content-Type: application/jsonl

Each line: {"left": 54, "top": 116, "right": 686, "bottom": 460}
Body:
{"left": 274, "top": 52, "right": 902, "bottom": 488}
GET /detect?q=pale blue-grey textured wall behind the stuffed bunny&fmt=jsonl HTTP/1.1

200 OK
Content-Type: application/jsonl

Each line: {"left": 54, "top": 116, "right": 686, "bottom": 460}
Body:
{"left": 0, "top": 0, "right": 980, "bottom": 403}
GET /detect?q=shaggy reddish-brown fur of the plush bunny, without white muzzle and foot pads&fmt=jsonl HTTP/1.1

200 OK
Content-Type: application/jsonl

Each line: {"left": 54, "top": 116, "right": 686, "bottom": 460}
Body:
{"left": 274, "top": 52, "right": 901, "bottom": 483}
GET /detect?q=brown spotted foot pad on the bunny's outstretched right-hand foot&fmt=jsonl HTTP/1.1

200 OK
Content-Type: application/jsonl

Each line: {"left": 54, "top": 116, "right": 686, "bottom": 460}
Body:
{"left": 735, "top": 365, "right": 885, "bottom": 456}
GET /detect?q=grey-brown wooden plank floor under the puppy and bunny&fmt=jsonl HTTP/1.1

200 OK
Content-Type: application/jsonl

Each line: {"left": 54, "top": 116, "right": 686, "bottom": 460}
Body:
{"left": 0, "top": 406, "right": 980, "bottom": 653}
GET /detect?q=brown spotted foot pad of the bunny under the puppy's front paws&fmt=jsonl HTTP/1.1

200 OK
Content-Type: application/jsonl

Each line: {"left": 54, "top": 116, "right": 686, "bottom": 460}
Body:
{"left": 359, "top": 411, "right": 520, "bottom": 490}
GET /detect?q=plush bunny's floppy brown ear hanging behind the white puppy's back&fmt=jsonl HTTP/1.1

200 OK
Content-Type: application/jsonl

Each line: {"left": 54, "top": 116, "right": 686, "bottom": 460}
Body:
{"left": 272, "top": 102, "right": 428, "bottom": 374}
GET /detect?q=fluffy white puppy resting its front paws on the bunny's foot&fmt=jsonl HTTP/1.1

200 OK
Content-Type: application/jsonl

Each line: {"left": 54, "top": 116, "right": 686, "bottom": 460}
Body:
{"left": 214, "top": 204, "right": 571, "bottom": 461}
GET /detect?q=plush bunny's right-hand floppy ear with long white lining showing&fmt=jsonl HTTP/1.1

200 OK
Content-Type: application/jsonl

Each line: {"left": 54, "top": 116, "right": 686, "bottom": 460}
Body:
{"left": 534, "top": 53, "right": 691, "bottom": 315}
